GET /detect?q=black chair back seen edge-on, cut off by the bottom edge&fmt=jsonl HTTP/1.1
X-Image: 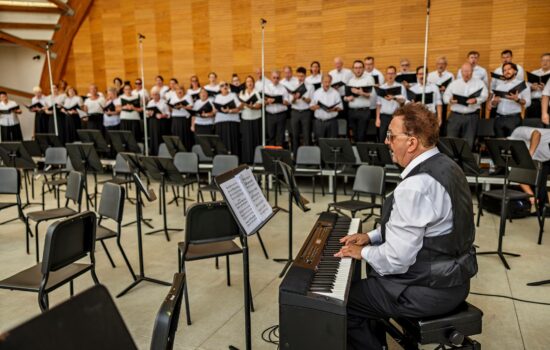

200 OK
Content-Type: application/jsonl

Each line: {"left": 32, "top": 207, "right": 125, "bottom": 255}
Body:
{"left": 151, "top": 273, "right": 185, "bottom": 350}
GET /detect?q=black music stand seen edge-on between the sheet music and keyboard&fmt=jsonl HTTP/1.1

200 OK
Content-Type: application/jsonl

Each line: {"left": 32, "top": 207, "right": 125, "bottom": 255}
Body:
{"left": 273, "top": 161, "right": 311, "bottom": 278}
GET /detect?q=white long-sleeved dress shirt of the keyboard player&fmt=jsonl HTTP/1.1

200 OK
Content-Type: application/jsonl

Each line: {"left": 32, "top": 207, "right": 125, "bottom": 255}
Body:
{"left": 361, "top": 147, "right": 453, "bottom": 276}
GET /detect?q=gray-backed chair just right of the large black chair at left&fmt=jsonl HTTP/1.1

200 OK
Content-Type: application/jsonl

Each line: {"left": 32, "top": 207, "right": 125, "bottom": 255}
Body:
{"left": 95, "top": 183, "right": 136, "bottom": 281}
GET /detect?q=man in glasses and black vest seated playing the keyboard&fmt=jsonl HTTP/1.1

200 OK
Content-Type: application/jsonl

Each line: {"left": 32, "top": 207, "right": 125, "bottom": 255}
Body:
{"left": 336, "top": 104, "right": 477, "bottom": 350}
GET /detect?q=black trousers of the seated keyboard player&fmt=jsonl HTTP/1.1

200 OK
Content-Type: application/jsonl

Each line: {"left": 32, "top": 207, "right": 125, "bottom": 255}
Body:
{"left": 347, "top": 277, "right": 470, "bottom": 350}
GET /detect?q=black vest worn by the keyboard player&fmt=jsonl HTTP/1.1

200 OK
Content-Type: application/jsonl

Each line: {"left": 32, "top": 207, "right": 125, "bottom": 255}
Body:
{"left": 378, "top": 153, "right": 477, "bottom": 288}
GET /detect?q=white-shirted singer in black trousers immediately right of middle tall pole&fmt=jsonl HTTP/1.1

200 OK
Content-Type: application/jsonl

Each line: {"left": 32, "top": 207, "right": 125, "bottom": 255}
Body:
{"left": 265, "top": 70, "right": 290, "bottom": 146}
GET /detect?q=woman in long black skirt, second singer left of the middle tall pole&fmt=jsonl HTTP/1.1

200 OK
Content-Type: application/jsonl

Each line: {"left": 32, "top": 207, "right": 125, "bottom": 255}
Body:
{"left": 214, "top": 81, "right": 241, "bottom": 157}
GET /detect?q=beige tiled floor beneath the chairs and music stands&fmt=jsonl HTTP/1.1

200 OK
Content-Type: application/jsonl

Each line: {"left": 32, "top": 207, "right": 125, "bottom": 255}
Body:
{"left": 0, "top": 176, "right": 550, "bottom": 350}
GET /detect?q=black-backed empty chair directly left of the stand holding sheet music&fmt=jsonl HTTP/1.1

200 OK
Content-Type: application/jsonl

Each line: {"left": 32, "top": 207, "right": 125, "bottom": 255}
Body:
{"left": 178, "top": 202, "right": 250, "bottom": 325}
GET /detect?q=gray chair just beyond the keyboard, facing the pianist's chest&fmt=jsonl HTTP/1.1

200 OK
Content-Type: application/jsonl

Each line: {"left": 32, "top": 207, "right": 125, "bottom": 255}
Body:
{"left": 328, "top": 165, "right": 386, "bottom": 221}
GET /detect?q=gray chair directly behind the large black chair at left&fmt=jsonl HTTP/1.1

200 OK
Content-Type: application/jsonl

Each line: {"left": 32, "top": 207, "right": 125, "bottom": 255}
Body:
{"left": 26, "top": 171, "right": 84, "bottom": 262}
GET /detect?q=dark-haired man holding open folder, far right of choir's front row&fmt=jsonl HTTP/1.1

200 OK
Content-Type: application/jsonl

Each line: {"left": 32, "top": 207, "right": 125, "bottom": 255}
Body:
{"left": 491, "top": 63, "right": 531, "bottom": 137}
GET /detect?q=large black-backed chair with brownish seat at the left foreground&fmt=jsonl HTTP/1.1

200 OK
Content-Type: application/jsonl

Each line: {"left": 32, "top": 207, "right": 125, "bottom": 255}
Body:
{"left": 0, "top": 212, "right": 99, "bottom": 311}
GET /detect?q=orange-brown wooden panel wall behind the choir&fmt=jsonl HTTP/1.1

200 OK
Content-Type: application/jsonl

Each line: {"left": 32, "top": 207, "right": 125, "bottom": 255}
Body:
{"left": 64, "top": 0, "right": 550, "bottom": 90}
